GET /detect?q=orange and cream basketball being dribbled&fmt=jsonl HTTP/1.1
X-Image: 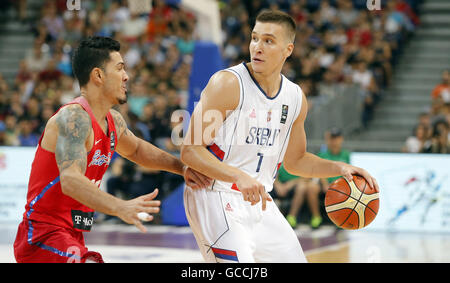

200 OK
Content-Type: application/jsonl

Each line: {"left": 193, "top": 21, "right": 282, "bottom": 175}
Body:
{"left": 325, "top": 176, "right": 379, "bottom": 230}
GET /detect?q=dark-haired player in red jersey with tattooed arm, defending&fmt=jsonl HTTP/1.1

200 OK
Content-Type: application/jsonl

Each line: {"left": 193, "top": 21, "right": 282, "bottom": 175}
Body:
{"left": 14, "top": 37, "right": 210, "bottom": 262}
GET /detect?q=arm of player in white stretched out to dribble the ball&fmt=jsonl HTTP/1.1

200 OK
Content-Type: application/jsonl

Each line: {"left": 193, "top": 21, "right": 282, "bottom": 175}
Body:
{"left": 284, "top": 92, "right": 378, "bottom": 189}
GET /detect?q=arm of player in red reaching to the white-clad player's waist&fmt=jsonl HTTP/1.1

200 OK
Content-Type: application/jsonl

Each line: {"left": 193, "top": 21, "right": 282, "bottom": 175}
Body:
{"left": 111, "top": 110, "right": 211, "bottom": 189}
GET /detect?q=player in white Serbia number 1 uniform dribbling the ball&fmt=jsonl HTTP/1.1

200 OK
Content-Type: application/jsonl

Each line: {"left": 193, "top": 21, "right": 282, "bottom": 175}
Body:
{"left": 181, "top": 11, "right": 378, "bottom": 262}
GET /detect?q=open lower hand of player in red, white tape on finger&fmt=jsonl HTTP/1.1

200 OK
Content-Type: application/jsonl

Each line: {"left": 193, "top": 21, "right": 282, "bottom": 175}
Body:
{"left": 116, "top": 189, "right": 161, "bottom": 233}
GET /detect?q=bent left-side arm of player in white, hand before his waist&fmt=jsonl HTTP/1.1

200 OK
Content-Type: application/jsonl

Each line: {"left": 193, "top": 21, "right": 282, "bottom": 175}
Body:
{"left": 181, "top": 71, "right": 271, "bottom": 209}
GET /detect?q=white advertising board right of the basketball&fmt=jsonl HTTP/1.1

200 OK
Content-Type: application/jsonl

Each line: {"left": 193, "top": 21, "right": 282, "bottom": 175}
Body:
{"left": 351, "top": 153, "right": 450, "bottom": 232}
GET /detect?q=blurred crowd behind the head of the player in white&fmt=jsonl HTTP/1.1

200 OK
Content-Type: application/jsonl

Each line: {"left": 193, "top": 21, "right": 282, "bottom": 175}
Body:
{"left": 221, "top": 0, "right": 420, "bottom": 127}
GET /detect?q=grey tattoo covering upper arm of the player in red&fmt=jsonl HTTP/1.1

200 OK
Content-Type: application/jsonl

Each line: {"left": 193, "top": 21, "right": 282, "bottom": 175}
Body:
{"left": 55, "top": 106, "right": 92, "bottom": 172}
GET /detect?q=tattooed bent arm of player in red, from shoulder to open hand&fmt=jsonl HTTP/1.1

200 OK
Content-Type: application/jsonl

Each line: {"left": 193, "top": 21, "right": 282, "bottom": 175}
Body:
{"left": 54, "top": 105, "right": 160, "bottom": 232}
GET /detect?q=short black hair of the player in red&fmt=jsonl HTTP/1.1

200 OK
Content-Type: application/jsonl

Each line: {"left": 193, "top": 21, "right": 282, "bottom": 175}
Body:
{"left": 72, "top": 36, "right": 120, "bottom": 87}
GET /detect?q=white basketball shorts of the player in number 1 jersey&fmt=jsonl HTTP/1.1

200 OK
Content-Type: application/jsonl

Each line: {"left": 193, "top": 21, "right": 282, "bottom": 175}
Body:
{"left": 184, "top": 187, "right": 306, "bottom": 263}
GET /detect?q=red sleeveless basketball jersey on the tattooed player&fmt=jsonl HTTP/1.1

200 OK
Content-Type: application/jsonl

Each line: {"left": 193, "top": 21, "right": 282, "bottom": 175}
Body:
{"left": 23, "top": 97, "right": 117, "bottom": 231}
